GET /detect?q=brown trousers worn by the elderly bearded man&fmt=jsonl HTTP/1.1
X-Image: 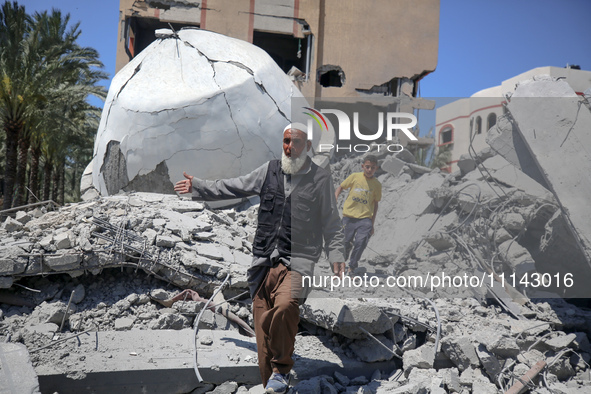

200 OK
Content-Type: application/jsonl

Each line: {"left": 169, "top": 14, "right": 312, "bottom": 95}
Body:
{"left": 253, "top": 263, "right": 302, "bottom": 386}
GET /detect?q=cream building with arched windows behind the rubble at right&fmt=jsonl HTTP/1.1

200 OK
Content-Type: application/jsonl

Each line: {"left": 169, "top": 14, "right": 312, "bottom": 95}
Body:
{"left": 435, "top": 67, "right": 591, "bottom": 172}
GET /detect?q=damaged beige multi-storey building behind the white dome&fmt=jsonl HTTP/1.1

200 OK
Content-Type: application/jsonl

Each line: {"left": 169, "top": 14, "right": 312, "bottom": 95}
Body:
{"left": 116, "top": 0, "right": 439, "bottom": 101}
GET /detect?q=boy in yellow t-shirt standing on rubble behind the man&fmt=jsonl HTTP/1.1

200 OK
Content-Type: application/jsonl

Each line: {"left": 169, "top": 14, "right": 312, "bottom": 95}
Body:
{"left": 335, "top": 155, "right": 382, "bottom": 274}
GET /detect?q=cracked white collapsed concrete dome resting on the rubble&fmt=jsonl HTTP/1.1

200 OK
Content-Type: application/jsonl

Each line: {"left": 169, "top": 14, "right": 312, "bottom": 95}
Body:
{"left": 88, "top": 29, "right": 314, "bottom": 195}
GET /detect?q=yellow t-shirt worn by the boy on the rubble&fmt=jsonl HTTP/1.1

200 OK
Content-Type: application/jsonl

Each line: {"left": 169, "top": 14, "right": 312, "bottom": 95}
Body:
{"left": 341, "top": 172, "right": 382, "bottom": 219}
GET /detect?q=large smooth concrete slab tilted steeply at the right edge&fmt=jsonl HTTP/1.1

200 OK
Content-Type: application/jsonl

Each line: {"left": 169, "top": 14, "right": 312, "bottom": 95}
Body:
{"left": 508, "top": 78, "right": 591, "bottom": 265}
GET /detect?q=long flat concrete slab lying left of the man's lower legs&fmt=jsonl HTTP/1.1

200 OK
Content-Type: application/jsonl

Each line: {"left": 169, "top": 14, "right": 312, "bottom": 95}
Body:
{"left": 36, "top": 329, "right": 258, "bottom": 393}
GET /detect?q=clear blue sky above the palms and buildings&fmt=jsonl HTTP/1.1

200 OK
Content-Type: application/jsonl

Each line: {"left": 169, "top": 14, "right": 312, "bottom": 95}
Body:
{"left": 18, "top": 0, "right": 591, "bottom": 105}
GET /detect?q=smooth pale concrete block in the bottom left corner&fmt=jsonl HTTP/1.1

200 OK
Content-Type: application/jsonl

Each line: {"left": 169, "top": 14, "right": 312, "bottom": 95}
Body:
{"left": 0, "top": 342, "right": 40, "bottom": 394}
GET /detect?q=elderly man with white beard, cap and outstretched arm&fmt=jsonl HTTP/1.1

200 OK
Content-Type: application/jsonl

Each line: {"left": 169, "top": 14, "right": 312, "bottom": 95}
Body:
{"left": 174, "top": 123, "right": 345, "bottom": 393}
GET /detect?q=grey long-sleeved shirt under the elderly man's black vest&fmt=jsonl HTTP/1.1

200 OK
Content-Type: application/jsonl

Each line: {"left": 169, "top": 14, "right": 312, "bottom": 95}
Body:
{"left": 193, "top": 159, "right": 345, "bottom": 296}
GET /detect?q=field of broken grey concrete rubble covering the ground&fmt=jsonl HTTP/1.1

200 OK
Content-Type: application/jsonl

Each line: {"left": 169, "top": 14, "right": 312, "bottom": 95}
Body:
{"left": 0, "top": 75, "right": 591, "bottom": 394}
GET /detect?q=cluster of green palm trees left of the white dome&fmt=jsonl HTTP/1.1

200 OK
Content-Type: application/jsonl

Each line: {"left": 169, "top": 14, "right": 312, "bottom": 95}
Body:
{"left": 0, "top": 1, "right": 106, "bottom": 208}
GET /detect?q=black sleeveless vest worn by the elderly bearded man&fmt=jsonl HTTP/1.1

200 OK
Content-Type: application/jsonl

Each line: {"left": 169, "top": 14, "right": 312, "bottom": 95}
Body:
{"left": 253, "top": 160, "right": 330, "bottom": 261}
